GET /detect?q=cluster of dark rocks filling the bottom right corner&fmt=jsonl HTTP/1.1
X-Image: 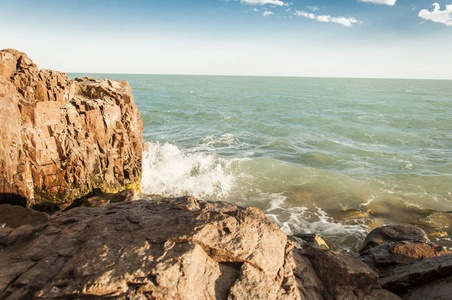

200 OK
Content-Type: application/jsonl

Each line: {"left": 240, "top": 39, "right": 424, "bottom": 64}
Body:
{"left": 358, "top": 226, "right": 452, "bottom": 299}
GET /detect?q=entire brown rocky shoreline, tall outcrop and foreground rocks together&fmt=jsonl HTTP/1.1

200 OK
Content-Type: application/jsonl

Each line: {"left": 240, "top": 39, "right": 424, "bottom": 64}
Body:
{"left": 0, "top": 49, "right": 452, "bottom": 300}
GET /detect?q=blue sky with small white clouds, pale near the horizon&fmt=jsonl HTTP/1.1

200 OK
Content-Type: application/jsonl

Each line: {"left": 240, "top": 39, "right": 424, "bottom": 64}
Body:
{"left": 0, "top": 0, "right": 452, "bottom": 79}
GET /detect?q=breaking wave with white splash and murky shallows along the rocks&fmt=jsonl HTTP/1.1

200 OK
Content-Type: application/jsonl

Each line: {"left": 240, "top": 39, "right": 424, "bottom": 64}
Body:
{"left": 142, "top": 142, "right": 451, "bottom": 253}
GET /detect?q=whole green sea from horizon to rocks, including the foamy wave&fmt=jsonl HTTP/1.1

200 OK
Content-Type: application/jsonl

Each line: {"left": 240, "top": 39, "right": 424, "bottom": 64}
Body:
{"left": 69, "top": 74, "right": 452, "bottom": 254}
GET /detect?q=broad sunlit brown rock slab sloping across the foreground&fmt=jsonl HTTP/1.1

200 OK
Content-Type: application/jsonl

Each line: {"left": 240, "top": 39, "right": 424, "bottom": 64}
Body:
{"left": 0, "top": 197, "right": 399, "bottom": 300}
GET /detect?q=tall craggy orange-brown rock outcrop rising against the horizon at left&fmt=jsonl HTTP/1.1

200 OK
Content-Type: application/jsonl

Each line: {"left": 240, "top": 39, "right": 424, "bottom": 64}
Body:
{"left": 0, "top": 49, "right": 142, "bottom": 209}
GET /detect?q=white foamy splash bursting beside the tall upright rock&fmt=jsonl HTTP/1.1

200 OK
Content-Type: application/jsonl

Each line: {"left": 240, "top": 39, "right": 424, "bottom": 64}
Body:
{"left": 142, "top": 143, "right": 240, "bottom": 199}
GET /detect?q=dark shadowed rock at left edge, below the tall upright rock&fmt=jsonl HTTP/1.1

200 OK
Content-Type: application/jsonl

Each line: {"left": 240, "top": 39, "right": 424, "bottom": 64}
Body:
{"left": 0, "top": 204, "right": 50, "bottom": 228}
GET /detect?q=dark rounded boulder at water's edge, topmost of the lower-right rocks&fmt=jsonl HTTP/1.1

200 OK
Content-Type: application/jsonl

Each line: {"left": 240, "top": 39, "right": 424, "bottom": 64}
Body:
{"left": 359, "top": 225, "right": 430, "bottom": 253}
